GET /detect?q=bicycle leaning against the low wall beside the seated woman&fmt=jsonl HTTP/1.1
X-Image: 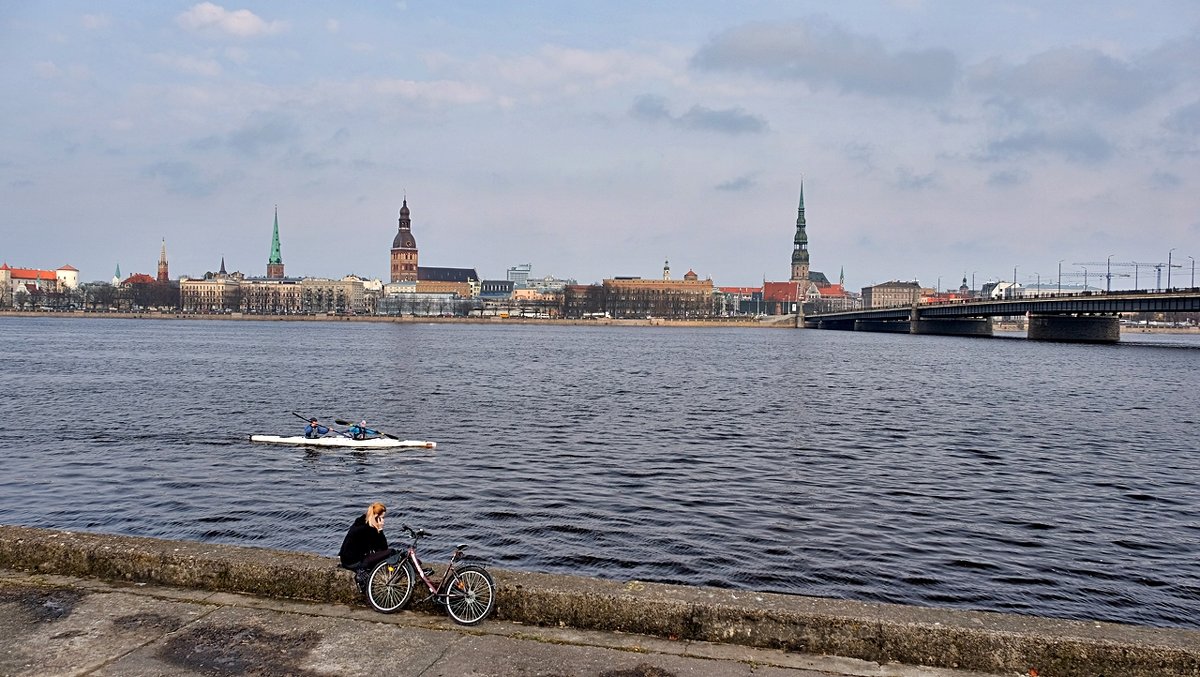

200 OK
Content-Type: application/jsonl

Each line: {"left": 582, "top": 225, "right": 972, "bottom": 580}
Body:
{"left": 367, "top": 525, "right": 496, "bottom": 625}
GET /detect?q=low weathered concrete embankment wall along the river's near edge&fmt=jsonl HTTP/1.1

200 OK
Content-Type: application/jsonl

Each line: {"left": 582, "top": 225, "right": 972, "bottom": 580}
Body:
{"left": 0, "top": 526, "right": 1200, "bottom": 677}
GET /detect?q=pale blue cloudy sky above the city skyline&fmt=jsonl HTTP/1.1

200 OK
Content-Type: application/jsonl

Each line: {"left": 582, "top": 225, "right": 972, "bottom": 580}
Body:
{"left": 0, "top": 0, "right": 1200, "bottom": 289}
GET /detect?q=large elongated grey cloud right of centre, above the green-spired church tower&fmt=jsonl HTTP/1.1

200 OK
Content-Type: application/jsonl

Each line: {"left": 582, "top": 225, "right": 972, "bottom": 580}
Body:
{"left": 691, "top": 18, "right": 959, "bottom": 98}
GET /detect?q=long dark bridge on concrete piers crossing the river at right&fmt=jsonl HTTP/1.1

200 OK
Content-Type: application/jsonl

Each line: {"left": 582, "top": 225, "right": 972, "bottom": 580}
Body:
{"left": 803, "top": 287, "right": 1200, "bottom": 343}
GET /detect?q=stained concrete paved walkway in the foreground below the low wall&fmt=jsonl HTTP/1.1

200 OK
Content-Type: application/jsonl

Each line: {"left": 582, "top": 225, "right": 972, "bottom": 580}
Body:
{"left": 0, "top": 570, "right": 1003, "bottom": 677}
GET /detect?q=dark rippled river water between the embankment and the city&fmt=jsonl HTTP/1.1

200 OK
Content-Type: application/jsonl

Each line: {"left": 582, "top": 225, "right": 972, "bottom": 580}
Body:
{"left": 0, "top": 317, "right": 1200, "bottom": 628}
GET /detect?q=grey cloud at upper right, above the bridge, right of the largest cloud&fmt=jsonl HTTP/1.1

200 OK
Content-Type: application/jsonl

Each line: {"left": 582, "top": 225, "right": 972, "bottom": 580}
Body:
{"left": 971, "top": 47, "right": 1165, "bottom": 112}
